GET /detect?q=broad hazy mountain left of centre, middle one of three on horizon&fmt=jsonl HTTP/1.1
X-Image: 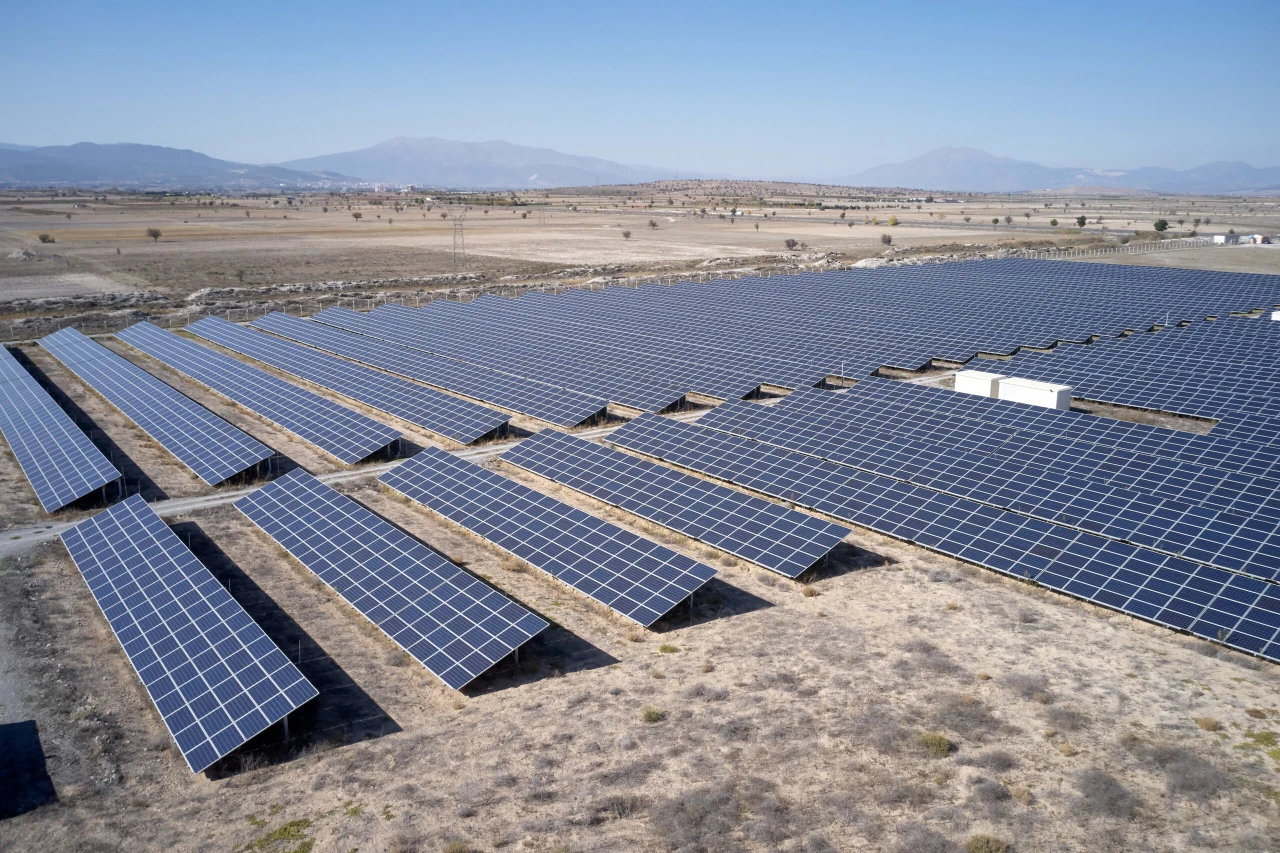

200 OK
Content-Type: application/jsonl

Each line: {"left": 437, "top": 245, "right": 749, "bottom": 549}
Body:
{"left": 280, "top": 137, "right": 676, "bottom": 190}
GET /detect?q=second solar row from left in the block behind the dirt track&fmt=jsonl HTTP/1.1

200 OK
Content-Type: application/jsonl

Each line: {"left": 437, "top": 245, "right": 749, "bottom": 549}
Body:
{"left": 40, "top": 328, "right": 275, "bottom": 485}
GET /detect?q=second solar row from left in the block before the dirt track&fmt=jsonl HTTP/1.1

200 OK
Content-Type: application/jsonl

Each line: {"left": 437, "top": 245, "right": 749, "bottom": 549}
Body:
{"left": 236, "top": 469, "right": 548, "bottom": 690}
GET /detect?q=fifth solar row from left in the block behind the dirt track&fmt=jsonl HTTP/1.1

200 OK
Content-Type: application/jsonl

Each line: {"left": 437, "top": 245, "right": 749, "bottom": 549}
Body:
{"left": 253, "top": 313, "right": 608, "bottom": 427}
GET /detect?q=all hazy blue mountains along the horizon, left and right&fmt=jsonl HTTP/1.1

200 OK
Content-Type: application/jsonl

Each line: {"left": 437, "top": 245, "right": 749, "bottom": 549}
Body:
{"left": 0, "top": 137, "right": 1280, "bottom": 195}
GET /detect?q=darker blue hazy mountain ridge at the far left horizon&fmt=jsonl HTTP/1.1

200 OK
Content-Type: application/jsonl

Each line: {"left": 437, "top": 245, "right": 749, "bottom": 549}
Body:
{"left": 0, "top": 142, "right": 358, "bottom": 190}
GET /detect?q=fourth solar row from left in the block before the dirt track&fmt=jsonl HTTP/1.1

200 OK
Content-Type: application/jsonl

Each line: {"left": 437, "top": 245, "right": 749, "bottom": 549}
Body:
{"left": 502, "top": 430, "right": 849, "bottom": 578}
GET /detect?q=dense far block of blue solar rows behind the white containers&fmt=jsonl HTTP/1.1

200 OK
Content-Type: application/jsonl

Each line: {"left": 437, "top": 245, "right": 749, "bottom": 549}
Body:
{"left": 296, "top": 259, "right": 1280, "bottom": 411}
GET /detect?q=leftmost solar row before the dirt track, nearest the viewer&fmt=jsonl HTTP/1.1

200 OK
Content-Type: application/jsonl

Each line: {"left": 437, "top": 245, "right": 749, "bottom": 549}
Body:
{"left": 63, "top": 494, "right": 319, "bottom": 772}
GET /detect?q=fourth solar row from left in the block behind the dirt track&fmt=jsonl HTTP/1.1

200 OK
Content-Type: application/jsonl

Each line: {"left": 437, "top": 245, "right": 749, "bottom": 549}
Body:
{"left": 187, "top": 316, "right": 509, "bottom": 444}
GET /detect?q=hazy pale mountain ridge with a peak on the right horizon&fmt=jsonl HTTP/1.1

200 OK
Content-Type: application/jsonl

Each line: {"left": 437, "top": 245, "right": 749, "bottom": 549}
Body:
{"left": 838, "top": 149, "right": 1280, "bottom": 193}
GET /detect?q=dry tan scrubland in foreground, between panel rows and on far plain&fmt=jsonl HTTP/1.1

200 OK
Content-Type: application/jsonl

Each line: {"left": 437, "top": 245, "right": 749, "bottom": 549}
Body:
{"left": 0, "top": 180, "right": 1280, "bottom": 853}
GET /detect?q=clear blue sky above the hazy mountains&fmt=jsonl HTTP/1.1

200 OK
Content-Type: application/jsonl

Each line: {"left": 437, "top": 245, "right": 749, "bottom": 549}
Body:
{"left": 0, "top": 0, "right": 1280, "bottom": 178}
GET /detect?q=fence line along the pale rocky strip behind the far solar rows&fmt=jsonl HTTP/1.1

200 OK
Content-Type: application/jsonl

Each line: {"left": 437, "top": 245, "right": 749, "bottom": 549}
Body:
{"left": 3, "top": 237, "right": 1213, "bottom": 342}
